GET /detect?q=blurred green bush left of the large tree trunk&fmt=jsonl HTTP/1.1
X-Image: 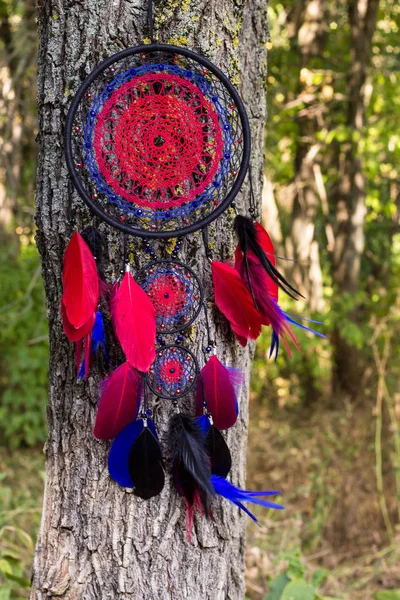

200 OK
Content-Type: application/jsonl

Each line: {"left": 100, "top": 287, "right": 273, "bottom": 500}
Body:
{"left": 0, "top": 242, "right": 48, "bottom": 448}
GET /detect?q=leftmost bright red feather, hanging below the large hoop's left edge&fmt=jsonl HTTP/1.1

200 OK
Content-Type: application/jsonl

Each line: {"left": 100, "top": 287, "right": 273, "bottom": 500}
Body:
{"left": 62, "top": 233, "right": 99, "bottom": 329}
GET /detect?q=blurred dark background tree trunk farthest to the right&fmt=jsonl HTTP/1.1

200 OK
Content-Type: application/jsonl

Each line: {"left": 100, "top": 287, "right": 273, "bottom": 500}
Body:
{"left": 332, "top": 0, "right": 379, "bottom": 397}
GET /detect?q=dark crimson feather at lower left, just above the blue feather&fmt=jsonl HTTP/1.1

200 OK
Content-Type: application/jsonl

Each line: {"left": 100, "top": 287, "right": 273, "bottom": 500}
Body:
{"left": 94, "top": 362, "right": 143, "bottom": 440}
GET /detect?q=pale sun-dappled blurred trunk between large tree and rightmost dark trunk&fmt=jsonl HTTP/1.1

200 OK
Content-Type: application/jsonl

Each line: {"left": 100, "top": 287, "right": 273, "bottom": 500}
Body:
{"left": 286, "top": 0, "right": 327, "bottom": 310}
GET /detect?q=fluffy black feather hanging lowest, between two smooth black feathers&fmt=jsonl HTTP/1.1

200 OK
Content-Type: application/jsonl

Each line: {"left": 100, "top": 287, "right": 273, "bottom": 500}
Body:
{"left": 168, "top": 413, "right": 214, "bottom": 512}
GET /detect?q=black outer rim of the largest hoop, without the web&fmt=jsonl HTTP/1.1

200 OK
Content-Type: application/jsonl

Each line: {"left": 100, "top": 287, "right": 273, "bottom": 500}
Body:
{"left": 64, "top": 44, "right": 251, "bottom": 239}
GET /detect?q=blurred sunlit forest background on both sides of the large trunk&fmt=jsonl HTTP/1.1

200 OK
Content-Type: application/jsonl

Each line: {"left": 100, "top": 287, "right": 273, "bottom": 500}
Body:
{"left": 0, "top": 0, "right": 400, "bottom": 600}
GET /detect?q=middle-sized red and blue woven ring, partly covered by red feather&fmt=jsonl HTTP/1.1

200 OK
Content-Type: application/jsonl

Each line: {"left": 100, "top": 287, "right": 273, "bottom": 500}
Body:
{"left": 136, "top": 261, "right": 202, "bottom": 334}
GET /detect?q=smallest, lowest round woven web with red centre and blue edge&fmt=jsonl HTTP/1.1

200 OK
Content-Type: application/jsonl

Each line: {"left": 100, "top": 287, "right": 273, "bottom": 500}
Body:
{"left": 146, "top": 346, "right": 198, "bottom": 400}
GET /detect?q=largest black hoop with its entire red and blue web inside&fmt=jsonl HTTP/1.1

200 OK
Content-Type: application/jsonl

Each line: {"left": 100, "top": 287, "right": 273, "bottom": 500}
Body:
{"left": 65, "top": 44, "right": 250, "bottom": 238}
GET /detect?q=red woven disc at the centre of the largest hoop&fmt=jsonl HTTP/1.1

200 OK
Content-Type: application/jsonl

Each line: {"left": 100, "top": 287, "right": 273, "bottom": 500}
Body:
{"left": 93, "top": 73, "right": 223, "bottom": 209}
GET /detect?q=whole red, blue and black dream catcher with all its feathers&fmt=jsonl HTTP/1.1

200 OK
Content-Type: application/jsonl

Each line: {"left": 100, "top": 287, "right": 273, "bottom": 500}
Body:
{"left": 61, "top": 3, "right": 324, "bottom": 538}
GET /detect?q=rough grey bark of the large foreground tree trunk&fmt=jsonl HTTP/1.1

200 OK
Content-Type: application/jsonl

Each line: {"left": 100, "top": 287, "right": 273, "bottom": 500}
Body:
{"left": 31, "top": 0, "right": 267, "bottom": 600}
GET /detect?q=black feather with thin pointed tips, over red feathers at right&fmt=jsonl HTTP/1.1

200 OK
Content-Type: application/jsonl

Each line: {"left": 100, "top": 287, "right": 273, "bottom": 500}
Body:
{"left": 235, "top": 215, "right": 304, "bottom": 306}
